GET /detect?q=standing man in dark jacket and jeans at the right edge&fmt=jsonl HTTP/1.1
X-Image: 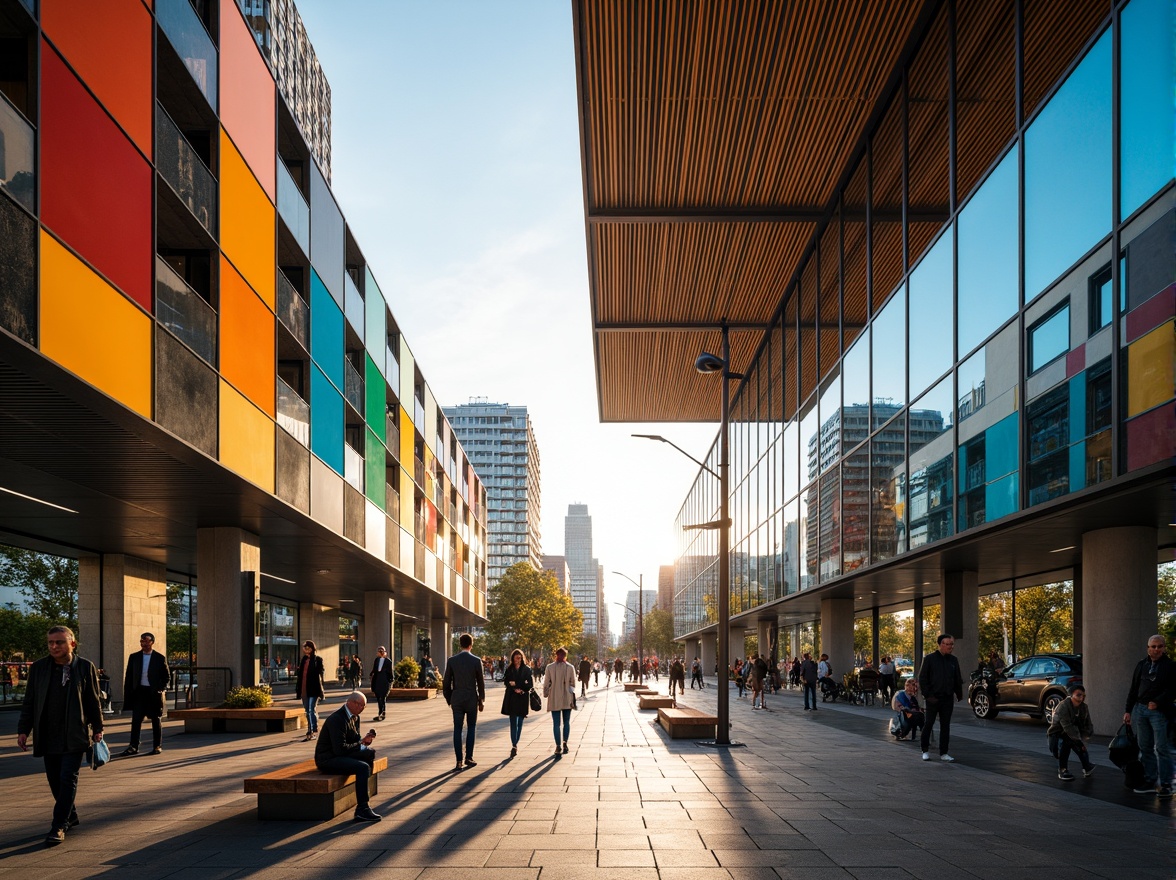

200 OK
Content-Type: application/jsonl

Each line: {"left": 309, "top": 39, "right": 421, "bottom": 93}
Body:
{"left": 1123, "top": 634, "right": 1176, "bottom": 798}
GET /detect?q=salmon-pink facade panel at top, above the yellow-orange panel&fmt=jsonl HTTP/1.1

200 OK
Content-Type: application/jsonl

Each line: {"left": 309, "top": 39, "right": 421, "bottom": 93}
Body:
{"left": 220, "top": 2, "right": 278, "bottom": 201}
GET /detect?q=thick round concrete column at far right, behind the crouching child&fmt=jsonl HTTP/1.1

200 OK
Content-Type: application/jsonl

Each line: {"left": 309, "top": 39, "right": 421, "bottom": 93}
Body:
{"left": 1075, "top": 526, "right": 1157, "bottom": 735}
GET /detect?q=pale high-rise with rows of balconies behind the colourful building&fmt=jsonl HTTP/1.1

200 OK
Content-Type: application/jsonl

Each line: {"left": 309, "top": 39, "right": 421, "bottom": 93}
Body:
{"left": 445, "top": 398, "right": 543, "bottom": 587}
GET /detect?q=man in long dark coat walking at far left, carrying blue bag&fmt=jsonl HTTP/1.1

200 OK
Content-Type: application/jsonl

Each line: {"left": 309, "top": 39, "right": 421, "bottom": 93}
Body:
{"left": 16, "top": 626, "right": 102, "bottom": 846}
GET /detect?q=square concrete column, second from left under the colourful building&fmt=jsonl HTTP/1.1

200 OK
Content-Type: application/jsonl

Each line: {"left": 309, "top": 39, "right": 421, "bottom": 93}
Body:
{"left": 196, "top": 527, "right": 261, "bottom": 706}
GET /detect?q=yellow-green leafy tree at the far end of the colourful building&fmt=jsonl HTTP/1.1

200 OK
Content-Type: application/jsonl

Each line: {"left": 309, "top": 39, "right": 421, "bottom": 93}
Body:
{"left": 482, "top": 562, "right": 583, "bottom": 656}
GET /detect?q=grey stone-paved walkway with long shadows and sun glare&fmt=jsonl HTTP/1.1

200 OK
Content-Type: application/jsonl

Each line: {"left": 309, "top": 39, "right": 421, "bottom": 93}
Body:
{"left": 0, "top": 680, "right": 1176, "bottom": 880}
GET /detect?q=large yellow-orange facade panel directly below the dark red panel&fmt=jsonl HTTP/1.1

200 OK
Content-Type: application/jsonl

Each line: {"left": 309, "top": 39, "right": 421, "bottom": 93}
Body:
{"left": 41, "top": 229, "right": 154, "bottom": 419}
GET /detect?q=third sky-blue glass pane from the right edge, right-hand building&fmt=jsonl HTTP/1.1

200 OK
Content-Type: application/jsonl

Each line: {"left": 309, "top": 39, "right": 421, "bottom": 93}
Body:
{"left": 956, "top": 146, "right": 1021, "bottom": 356}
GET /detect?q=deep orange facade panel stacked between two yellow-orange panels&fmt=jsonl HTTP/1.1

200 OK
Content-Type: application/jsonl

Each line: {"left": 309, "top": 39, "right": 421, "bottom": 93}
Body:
{"left": 220, "top": 256, "right": 275, "bottom": 418}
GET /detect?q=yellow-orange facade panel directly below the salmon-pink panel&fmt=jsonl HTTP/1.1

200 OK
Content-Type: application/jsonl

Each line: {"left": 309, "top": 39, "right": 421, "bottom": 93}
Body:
{"left": 220, "top": 129, "right": 278, "bottom": 308}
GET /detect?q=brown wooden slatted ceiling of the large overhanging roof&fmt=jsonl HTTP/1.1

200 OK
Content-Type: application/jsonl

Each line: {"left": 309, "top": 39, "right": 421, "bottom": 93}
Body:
{"left": 573, "top": 0, "right": 924, "bottom": 421}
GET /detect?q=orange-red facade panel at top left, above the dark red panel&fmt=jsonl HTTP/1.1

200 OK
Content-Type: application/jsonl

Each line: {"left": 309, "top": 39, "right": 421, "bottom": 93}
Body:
{"left": 41, "top": 0, "right": 154, "bottom": 156}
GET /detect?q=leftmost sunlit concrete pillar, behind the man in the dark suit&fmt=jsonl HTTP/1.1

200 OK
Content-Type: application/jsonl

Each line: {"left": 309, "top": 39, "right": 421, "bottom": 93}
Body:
{"left": 76, "top": 553, "right": 167, "bottom": 702}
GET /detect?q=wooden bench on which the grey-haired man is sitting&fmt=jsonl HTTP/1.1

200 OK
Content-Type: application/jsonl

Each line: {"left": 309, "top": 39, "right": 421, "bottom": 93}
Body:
{"left": 245, "top": 758, "right": 388, "bottom": 820}
